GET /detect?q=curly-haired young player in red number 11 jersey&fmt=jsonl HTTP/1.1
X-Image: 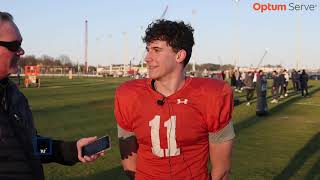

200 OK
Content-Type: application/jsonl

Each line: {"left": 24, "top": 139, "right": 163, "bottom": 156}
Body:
{"left": 115, "top": 20, "right": 235, "bottom": 180}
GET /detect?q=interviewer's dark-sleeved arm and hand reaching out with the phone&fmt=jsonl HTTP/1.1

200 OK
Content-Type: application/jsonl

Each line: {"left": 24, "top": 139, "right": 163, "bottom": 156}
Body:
{"left": 7, "top": 80, "right": 104, "bottom": 165}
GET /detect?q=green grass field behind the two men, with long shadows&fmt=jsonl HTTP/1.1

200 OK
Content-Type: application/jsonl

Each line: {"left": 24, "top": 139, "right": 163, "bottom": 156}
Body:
{"left": 18, "top": 78, "right": 320, "bottom": 180}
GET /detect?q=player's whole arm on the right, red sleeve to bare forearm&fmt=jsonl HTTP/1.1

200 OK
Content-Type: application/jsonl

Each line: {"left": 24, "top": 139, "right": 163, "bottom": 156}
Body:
{"left": 207, "top": 84, "right": 235, "bottom": 180}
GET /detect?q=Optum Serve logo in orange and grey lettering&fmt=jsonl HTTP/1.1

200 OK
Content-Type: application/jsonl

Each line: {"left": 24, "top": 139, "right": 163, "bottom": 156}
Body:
{"left": 252, "top": 3, "right": 317, "bottom": 13}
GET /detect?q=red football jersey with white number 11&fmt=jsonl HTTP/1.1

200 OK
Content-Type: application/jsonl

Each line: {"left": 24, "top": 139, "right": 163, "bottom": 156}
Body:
{"left": 115, "top": 77, "right": 233, "bottom": 180}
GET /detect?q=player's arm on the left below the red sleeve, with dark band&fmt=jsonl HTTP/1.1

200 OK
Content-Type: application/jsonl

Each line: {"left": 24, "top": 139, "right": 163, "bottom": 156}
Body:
{"left": 118, "top": 125, "right": 139, "bottom": 180}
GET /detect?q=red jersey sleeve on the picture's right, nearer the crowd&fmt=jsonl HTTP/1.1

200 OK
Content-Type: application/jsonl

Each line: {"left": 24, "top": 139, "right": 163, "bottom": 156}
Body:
{"left": 206, "top": 83, "right": 233, "bottom": 133}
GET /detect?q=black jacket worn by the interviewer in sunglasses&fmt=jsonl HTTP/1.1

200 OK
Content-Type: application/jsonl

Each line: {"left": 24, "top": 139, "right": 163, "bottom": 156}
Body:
{"left": 0, "top": 79, "right": 78, "bottom": 180}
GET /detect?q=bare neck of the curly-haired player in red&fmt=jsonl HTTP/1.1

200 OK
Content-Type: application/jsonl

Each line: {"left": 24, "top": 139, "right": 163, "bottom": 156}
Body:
{"left": 154, "top": 74, "right": 186, "bottom": 97}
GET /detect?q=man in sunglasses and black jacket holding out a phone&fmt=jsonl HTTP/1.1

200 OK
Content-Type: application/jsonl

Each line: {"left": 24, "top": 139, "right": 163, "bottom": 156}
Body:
{"left": 0, "top": 12, "right": 104, "bottom": 180}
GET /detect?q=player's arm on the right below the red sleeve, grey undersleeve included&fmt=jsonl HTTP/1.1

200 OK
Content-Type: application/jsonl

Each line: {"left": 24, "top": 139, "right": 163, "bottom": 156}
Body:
{"left": 209, "top": 122, "right": 235, "bottom": 180}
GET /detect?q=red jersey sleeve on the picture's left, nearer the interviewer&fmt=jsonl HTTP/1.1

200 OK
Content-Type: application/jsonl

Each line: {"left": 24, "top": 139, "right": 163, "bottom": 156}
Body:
{"left": 114, "top": 89, "right": 133, "bottom": 132}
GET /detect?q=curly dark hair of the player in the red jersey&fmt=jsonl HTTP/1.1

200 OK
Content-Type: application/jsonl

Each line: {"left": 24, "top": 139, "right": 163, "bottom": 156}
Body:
{"left": 142, "top": 19, "right": 194, "bottom": 66}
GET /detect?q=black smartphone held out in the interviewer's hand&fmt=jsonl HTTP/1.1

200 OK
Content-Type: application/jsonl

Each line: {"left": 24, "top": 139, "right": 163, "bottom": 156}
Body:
{"left": 82, "top": 136, "right": 111, "bottom": 156}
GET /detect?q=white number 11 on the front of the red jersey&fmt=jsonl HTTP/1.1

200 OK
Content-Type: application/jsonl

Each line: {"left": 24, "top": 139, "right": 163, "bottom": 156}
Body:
{"left": 149, "top": 115, "right": 180, "bottom": 157}
